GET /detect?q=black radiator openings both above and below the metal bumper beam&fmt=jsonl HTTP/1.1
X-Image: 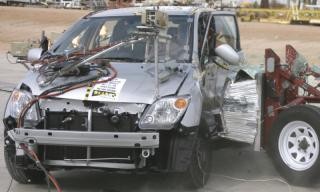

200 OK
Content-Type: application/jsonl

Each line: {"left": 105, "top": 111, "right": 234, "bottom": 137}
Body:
{"left": 44, "top": 111, "right": 141, "bottom": 160}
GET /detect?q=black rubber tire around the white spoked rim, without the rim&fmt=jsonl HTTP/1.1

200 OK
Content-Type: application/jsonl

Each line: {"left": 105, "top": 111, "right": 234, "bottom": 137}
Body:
{"left": 268, "top": 105, "right": 320, "bottom": 186}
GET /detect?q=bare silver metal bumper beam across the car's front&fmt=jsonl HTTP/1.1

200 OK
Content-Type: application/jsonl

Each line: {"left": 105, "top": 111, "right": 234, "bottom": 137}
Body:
{"left": 8, "top": 128, "right": 159, "bottom": 148}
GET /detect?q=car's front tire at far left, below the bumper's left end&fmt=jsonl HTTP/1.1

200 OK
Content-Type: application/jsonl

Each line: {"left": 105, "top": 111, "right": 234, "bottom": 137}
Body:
{"left": 4, "top": 142, "right": 45, "bottom": 184}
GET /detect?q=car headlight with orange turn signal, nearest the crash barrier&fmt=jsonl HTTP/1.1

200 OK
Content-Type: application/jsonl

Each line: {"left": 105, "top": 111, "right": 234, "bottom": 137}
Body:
{"left": 139, "top": 96, "right": 190, "bottom": 129}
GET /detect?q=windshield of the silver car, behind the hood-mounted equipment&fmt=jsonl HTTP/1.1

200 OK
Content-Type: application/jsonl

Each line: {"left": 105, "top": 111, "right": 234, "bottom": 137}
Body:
{"left": 50, "top": 15, "right": 193, "bottom": 62}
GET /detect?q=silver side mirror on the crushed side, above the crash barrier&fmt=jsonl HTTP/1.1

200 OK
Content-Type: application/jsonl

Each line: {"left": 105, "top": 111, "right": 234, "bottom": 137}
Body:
{"left": 215, "top": 44, "right": 240, "bottom": 65}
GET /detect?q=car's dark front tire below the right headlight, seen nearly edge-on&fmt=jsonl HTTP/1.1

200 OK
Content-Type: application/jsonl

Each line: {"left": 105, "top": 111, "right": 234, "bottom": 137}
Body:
{"left": 187, "top": 137, "right": 211, "bottom": 189}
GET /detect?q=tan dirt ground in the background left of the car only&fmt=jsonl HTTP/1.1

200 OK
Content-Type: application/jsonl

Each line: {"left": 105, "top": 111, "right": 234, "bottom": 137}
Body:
{"left": 0, "top": 6, "right": 89, "bottom": 52}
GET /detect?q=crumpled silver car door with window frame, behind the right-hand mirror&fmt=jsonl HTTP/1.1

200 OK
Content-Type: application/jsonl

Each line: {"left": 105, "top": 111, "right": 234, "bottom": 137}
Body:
{"left": 198, "top": 13, "right": 240, "bottom": 111}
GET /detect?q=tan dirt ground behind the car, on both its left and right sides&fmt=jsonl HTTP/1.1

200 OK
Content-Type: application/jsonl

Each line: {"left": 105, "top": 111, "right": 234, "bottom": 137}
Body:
{"left": 0, "top": 7, "right": 320, "bottom": 64}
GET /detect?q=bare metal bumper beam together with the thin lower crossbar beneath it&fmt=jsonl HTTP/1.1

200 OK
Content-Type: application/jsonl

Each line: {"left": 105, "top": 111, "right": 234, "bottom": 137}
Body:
{"left": 7, "top": 128, "right": 159, "bottom": 170}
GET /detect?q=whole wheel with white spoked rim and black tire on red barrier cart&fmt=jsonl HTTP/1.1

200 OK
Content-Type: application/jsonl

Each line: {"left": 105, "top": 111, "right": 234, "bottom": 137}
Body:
{"left": 268, "top": 105, "right": 320, "bottom": 186}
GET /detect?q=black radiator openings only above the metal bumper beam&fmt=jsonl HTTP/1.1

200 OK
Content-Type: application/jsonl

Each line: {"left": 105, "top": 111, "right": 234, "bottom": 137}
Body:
{"left": 45, "top": 111, "right": 137, "bottom": 132}
